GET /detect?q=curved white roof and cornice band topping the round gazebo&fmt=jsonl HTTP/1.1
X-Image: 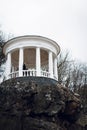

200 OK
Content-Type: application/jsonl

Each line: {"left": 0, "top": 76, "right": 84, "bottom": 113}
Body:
{"left": 3, "top": 35, "right": 60, "bottom": 55}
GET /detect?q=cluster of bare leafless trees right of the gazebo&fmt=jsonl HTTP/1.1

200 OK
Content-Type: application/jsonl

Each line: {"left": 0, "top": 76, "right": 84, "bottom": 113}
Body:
{"left": 58, "top": 49, "right": 87, "bottom": 92}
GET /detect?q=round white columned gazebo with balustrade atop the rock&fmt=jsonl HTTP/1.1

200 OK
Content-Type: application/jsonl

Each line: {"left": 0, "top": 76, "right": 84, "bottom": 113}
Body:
{"left": 3, "top": 35, "right": 60, "bottom": 80}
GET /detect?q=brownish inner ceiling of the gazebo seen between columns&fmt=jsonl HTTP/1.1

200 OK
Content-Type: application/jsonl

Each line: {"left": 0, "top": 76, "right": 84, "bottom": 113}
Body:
{"left": 12, "top": 48, "right": 48, "bottom": 67}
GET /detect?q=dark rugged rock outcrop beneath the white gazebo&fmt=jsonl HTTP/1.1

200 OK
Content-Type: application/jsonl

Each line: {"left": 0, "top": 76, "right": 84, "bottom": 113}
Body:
{"left": 0, "top": 77, "right": 81, "bottom": 130}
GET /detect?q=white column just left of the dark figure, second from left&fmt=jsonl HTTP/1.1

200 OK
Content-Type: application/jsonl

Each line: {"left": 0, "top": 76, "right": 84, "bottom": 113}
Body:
{"left": 19, "top": 48, "right": 24, "bottom": 77}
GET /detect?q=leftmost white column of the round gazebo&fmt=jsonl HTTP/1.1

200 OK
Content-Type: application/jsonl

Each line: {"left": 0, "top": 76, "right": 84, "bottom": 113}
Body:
{"left": 5, "top": 52, "right": 11, "bottom": 79}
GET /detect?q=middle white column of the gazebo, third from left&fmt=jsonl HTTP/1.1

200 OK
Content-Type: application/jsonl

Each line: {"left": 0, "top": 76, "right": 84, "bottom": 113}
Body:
{"left": 36, "top": 47, "right": 41, "bottom": 76}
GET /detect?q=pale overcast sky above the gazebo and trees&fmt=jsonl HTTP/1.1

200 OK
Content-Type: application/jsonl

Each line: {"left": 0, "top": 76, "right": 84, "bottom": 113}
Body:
{"left": 0, "top": 0, "right": 87, "bottom": 62}
